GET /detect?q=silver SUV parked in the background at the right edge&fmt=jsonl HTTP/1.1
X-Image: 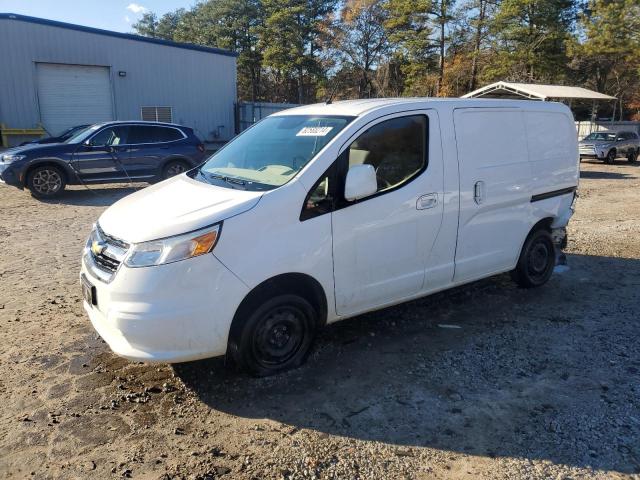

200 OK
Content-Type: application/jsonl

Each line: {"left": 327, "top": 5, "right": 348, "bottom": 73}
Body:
{"left": 580, "top": 131, "right": 640, "bottom": 163}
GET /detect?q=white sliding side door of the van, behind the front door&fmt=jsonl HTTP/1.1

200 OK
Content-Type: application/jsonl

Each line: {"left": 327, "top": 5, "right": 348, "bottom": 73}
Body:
{"left": 454, "top": 108, "right": 532, "bottom": 282}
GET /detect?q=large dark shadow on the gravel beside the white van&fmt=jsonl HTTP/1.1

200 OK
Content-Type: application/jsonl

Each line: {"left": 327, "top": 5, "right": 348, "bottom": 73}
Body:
{"left": 173, "top": 255, "right": 640, "bottom": 473}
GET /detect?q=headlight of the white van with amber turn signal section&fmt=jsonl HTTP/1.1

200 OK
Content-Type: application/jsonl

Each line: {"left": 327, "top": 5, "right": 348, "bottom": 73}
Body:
{"left": 124, "top": 223, "right": 222, "bottom": 268}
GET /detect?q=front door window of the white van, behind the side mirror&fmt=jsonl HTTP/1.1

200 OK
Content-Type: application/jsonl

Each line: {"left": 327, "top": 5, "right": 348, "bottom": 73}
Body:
{"left": 347, "top": 115, "right": 428, "bottom": 195}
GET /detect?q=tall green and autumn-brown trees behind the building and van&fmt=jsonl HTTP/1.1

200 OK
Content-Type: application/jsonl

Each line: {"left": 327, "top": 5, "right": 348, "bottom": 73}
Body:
{"left": 134, "top": 0, "right": 640, "bottom": 116}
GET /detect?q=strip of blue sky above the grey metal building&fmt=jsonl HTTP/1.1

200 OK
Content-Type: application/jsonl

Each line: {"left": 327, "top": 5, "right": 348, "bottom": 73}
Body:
{"left": 0, "top": 0, "right": 196, "bottom": 32}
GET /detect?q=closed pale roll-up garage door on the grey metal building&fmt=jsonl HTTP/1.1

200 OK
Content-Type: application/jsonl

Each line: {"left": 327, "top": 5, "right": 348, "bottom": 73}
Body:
{"left": 36, "top": 63, "right": 113, "bottom": 135}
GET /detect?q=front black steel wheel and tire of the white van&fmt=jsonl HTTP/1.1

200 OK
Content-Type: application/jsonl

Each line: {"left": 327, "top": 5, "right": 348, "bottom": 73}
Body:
{"left": 233, "top": 294, "right": 318, "bottom": 377}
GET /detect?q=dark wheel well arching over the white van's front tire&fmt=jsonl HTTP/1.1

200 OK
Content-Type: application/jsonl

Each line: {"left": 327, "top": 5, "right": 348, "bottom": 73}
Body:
{"left": 227, "top": 273, "right": 327, "bottom": 351}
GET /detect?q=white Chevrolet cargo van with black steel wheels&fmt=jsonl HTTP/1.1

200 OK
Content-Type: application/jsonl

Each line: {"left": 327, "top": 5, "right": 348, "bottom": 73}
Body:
{"left": 81, "top": 99, "right": 579, "bottom": 375}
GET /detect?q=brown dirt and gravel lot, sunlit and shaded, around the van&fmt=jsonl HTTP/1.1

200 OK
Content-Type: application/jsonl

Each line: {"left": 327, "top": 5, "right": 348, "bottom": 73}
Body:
{"left": 0, "top": 160, "right": 640, "bottom": 479}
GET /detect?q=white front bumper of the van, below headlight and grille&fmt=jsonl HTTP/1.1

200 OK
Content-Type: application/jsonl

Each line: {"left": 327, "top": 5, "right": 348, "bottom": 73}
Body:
{"left": 82, "top": 254, "right": 248, "bottom": 362}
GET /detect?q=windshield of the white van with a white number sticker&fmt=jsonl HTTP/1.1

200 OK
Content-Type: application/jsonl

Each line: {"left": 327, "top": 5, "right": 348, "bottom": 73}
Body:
{"left": 195, "top": 115, "right": 353, "bottom": 190}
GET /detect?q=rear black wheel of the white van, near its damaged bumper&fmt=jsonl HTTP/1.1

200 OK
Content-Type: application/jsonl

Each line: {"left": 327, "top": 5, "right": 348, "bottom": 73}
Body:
{"left": 511, "top": 228, "right": 556, "bottom": 288}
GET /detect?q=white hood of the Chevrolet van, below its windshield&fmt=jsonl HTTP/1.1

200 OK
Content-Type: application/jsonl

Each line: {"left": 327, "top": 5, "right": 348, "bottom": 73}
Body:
{"left": 98, "top": 174, "right": 263, "bottom": 243}
